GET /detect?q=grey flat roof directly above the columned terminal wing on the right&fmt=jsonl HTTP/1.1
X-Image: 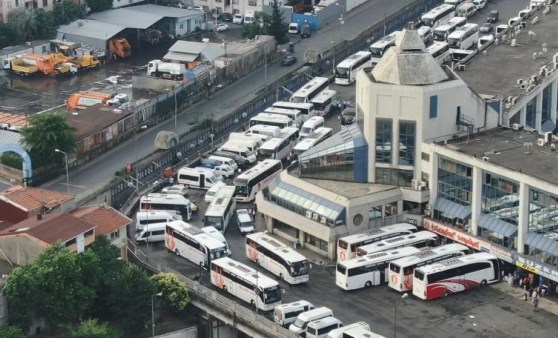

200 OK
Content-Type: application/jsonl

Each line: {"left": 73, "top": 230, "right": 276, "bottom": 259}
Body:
{"left": 439, "top": 128, "right": 558, "bottom": 184}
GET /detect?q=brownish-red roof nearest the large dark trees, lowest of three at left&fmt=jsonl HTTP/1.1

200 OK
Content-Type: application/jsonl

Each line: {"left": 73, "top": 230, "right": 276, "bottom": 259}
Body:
{"left": 0, "top": 213, "right": 95, "bottom": 244}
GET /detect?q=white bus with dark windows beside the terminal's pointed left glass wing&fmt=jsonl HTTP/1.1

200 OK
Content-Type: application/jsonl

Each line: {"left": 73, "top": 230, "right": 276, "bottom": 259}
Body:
{"left": 233, "top": 160, "right": 283, "bottom": 203}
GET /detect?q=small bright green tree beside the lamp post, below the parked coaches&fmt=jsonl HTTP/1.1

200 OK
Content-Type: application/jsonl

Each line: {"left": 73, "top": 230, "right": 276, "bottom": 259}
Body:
{"left": 151, "top": 272, "right": 190, "bottom": 312}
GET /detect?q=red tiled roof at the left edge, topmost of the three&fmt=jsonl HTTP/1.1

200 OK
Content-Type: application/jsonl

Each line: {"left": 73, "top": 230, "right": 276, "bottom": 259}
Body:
{"left": 0, "top": 185, "right": 75, "bottom": 211}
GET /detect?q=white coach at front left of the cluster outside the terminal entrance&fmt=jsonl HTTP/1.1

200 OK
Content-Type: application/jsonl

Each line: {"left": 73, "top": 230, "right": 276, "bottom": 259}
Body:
{"left": 335, "top": 246, "right": 420, "bottom": 290}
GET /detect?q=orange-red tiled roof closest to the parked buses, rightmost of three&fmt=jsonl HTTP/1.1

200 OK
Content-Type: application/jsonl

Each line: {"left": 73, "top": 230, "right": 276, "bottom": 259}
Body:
{"left": 71, "top": 205, "right": 132, "bottom": 235}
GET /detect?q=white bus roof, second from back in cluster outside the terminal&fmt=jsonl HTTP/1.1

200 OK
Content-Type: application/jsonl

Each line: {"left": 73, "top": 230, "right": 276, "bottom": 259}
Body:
{"left": 357, "top": 230, "right": 438, "bottom": 256}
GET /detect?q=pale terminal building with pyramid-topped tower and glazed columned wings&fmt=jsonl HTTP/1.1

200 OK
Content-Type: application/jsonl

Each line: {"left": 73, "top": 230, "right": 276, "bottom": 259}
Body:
{"left": 256, "top": 29, "right": 558, "bottom": 282}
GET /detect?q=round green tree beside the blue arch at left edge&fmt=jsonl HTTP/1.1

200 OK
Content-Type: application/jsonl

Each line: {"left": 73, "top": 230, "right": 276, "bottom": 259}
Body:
{"left": 21, "top": 112, "right": 75, "bottom": 166}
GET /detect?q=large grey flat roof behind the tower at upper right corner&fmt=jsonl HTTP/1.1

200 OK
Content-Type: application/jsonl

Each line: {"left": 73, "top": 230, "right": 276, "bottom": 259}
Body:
{"left": 458, "top": 10, "right": 558, "bottom": 98}
